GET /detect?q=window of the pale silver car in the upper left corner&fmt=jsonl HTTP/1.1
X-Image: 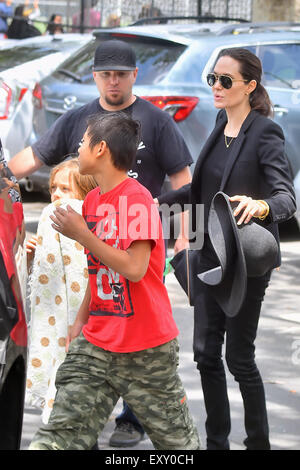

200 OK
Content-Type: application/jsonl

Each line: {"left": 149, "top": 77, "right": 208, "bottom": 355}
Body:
{"left": 0, "top": 41, "right": 82, "bottom": 72}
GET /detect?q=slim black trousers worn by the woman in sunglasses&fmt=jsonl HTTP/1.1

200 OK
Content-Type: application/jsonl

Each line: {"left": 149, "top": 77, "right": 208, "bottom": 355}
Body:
{"left": 193, "top": 241, "right": 270, "bottom": 450}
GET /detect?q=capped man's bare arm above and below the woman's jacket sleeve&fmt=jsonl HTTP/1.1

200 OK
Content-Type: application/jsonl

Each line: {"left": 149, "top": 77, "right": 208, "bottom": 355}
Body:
{"left": 169, "top": 166, "right": 192, "bottom": 254}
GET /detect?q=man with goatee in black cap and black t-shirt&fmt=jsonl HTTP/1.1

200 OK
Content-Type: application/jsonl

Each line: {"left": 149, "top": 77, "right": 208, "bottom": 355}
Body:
{"left": 9, "top": 40, "right": 193, "bottom": 447}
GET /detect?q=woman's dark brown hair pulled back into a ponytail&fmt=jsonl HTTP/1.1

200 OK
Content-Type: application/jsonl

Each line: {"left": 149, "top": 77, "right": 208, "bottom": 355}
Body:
{"left": 217, "top": 47, "right": 273, "bottom": 116}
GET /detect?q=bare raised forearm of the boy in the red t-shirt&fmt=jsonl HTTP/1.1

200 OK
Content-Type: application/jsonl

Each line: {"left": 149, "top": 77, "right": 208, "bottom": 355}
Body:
{"left": 50, "top": 206, "right": 152, "bottom": 282}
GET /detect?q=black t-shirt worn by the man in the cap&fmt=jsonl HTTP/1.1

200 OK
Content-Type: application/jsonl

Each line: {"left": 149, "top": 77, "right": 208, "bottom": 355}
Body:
{"left": 32, "top": 97, "right": 193, "bottom": 197}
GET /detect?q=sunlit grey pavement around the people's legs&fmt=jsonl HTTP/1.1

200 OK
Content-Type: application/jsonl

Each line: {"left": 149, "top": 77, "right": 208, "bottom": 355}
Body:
{"left": 21, "top": 241, "right": 300, "bottom": 455}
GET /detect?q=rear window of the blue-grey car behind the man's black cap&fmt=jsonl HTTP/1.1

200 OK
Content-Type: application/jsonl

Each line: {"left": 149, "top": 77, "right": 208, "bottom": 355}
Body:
{"left": 55, "top": 39, "right": 186, "bottom": 85}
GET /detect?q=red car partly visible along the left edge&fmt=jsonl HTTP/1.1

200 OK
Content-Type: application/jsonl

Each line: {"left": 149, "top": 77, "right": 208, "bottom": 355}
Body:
{"left": 0, "top": 141, "right": 27, "bottom": 450}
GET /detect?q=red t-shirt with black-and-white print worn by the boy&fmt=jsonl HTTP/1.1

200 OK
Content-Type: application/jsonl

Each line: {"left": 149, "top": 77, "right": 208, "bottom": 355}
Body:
{"left": 82, "top": 178, "right": 178, "bottom": 353}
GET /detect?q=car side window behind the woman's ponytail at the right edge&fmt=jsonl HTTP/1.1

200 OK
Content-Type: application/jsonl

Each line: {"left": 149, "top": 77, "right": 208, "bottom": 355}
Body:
{"left": 259, "top": 44, "right": 300, "bottom": 88}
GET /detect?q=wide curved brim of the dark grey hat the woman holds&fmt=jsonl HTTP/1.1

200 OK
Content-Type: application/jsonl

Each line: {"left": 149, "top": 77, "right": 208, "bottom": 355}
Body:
{"left": 198, "top": 192, "right": 247, "bottom": 317}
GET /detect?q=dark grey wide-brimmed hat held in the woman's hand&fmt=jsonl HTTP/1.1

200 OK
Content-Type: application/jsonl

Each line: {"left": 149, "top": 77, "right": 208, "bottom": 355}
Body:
{"left": 198, "top": 192, "right": 279, "bottom": 317}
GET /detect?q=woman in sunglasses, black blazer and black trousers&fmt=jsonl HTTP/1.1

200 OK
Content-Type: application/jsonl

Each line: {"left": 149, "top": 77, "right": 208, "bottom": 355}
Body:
{"left": 158, "top": 48, "right": 295, "bottom": 450}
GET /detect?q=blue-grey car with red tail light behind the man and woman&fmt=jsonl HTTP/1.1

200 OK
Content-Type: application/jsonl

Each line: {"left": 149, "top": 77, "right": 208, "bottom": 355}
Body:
{"left": 25, "top": 22, "right": 300, "bottom": 228}
